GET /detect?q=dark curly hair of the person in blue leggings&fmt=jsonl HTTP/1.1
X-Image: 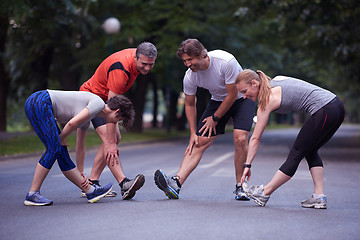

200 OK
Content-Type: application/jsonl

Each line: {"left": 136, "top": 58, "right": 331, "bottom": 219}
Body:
{"left": 106, "top": 95, "right": 135, "bottom": 129}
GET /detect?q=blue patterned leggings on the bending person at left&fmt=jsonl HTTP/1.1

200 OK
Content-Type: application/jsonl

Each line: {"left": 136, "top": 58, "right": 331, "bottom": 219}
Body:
{"left": 25, "top": 90, "right": 75, "bottom": 171}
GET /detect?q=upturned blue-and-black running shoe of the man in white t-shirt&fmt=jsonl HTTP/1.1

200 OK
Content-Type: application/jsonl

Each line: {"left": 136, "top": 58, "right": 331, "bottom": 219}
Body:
{"left": 154, "top": 169, "right": 181, "bottom": 199}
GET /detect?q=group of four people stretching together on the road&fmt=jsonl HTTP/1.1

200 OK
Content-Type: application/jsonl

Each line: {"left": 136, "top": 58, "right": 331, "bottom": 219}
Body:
{"left": 24, "top": 39, "right": 345, "bottom": 209}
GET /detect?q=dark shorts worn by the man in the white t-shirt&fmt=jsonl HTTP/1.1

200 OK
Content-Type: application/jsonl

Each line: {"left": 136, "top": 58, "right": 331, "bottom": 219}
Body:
{"left": 196, "top": 98, "right": 255, "bottom": 136}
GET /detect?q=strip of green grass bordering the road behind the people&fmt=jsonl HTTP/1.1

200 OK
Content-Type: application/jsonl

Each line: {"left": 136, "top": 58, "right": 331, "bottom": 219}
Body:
{"left": 0, "top": 129, "right": 189, "bottom": 157}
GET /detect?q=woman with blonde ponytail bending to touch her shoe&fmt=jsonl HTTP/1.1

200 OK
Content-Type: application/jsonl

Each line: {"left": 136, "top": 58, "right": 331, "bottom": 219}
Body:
{"left": 235, "top": 69, "right": 345, "bottom": 209}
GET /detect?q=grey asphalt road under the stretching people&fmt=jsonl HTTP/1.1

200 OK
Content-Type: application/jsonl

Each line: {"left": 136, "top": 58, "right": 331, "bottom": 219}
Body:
{"left": 0, "top": 125, "right": 360, "bottom": 240}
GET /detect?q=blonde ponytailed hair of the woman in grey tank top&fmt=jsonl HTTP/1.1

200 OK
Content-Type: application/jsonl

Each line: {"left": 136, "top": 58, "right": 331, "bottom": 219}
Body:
{"left": 235, "top": 69, "right": 271, "bottom": 111}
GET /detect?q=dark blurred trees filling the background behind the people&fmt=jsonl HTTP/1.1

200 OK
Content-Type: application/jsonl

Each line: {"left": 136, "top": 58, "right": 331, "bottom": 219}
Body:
{"left": 0, "top": 0, "right": 360, "bottom": 132}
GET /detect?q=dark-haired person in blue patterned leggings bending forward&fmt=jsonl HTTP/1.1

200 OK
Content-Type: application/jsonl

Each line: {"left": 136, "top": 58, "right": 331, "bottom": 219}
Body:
{"left": 24, "top": 90, "right": 133, "bottom": 206}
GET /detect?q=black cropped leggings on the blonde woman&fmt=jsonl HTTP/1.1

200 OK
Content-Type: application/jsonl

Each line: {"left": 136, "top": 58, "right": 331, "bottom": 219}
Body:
{"left": 279, "top": 97, "right": 345, "bottom": 177}
